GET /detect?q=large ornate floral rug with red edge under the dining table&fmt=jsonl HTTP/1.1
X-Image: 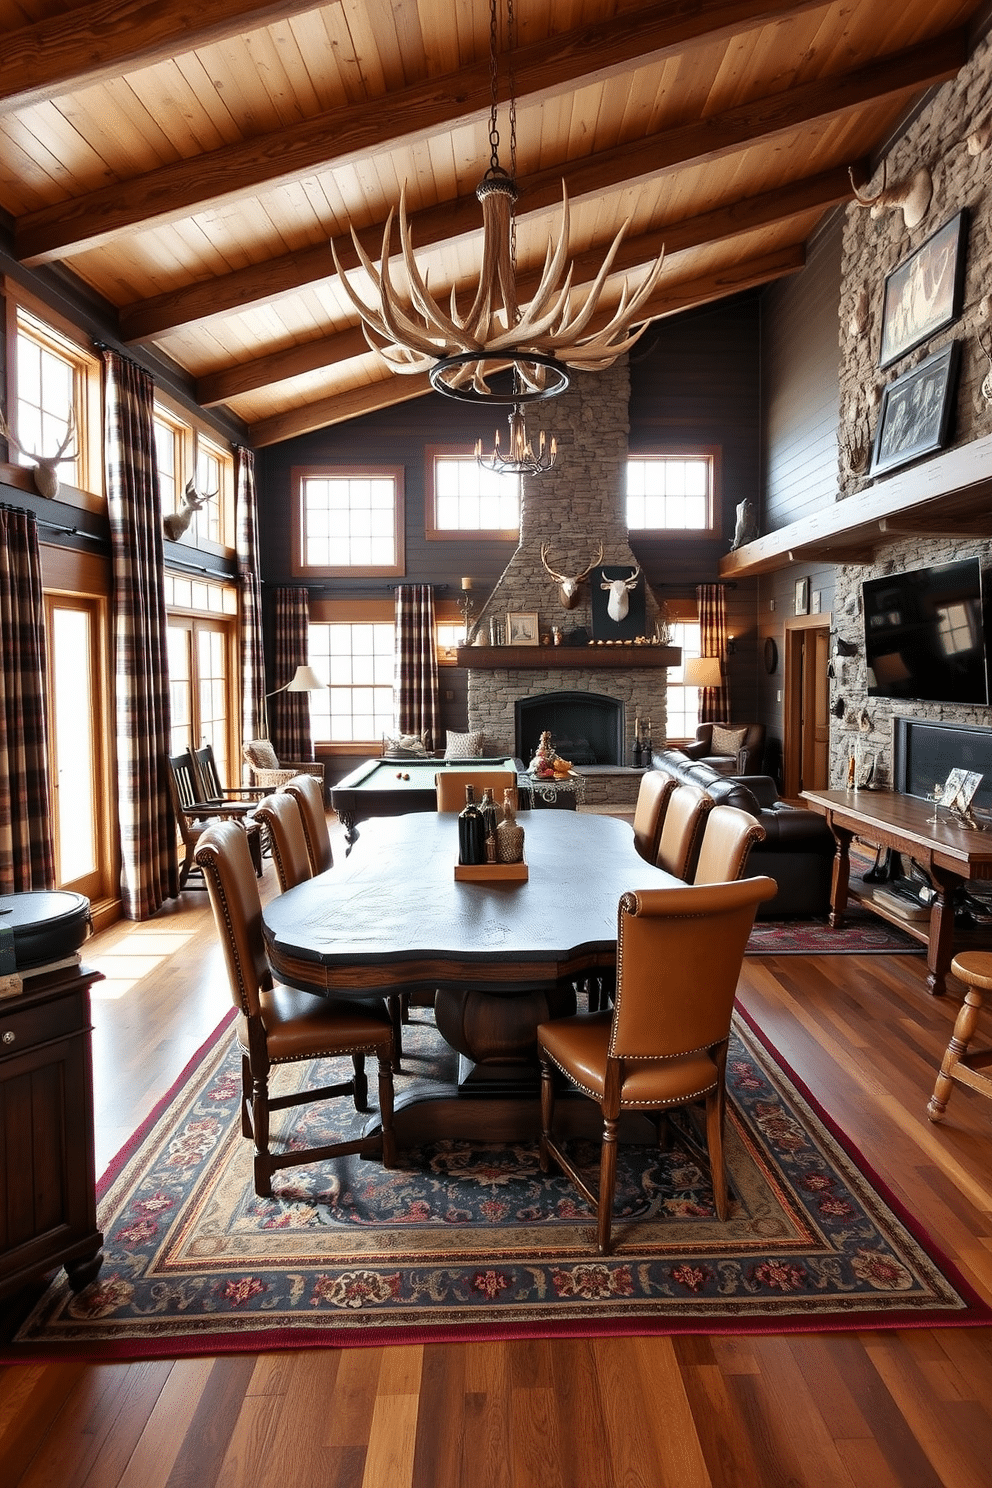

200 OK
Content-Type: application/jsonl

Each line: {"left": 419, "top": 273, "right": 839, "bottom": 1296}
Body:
{"left": 0, "top": 1010, "right": 992, "bottom": 1360}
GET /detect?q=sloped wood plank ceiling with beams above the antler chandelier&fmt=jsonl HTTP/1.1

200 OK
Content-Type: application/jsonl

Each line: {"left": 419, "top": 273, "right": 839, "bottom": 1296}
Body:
{"left": 0, "top": 0, "right": 982, "bottom": 445}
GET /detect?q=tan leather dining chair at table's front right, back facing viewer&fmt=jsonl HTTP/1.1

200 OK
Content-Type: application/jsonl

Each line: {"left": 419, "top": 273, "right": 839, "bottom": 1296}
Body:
{"left": 537, "top": 878, "right": 776, "bottom": 1254}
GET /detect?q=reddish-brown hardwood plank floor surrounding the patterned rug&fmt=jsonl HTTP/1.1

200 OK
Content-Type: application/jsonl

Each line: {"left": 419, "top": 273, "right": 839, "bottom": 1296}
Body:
{"left": 0, "top": 821, "right": 992, "bottom": 1488}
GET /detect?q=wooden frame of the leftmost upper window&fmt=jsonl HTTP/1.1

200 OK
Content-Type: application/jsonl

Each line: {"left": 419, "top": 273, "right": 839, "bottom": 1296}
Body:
{"left": 0, "top": 287, "right": 107, "bottom": 512}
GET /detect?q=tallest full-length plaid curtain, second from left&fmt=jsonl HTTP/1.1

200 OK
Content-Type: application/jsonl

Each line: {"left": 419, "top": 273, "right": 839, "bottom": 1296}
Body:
{"left": 104, "top": 350, "right": 178, "bottom": 920}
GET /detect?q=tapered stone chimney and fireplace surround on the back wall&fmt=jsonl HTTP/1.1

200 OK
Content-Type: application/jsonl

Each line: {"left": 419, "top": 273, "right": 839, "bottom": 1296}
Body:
{"left": 468, "top": 357, "right": 666, "bottom": 753}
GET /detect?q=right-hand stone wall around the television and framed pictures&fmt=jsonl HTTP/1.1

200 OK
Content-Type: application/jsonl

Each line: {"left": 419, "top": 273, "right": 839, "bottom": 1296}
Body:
{"left": 830, "top": 29, "right": 992, "bottom": 786}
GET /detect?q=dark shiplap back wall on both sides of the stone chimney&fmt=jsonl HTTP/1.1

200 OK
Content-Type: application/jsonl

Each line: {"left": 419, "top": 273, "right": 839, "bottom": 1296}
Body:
{"left": 257, "top": 295, "right": 760, "bottom": 744}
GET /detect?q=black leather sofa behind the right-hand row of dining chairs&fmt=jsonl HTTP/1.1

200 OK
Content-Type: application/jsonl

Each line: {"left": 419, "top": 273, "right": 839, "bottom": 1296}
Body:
{"left": 651, "top": 748, "right": 836, "bottom": 920}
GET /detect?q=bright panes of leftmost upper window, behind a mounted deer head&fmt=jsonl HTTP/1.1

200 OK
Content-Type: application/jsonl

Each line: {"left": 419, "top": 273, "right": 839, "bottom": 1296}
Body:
{"left": 7, "top": 302, "right": 103, "bottom": 509}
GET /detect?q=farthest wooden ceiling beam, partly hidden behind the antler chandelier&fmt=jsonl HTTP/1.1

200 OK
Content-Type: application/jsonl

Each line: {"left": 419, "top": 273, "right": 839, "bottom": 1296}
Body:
{"left": 250, "top": 244, "right": 806, "bottom": 449}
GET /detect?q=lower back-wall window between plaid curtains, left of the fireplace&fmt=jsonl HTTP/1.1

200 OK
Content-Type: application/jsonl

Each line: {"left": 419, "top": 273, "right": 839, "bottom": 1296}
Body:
{"left": 309, "top": 620, "right": 396, "bottom": 745}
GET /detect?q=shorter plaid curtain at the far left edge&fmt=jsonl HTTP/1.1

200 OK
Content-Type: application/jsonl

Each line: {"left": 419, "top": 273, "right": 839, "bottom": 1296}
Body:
{"left": 0, "top": 506, "right": 55, "bottom": 894}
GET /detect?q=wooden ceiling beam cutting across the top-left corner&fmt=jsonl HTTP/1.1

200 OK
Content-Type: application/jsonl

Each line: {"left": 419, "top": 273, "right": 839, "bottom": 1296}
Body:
{"left": 0, "top": 0, "right": 325, "bottom": 113}
